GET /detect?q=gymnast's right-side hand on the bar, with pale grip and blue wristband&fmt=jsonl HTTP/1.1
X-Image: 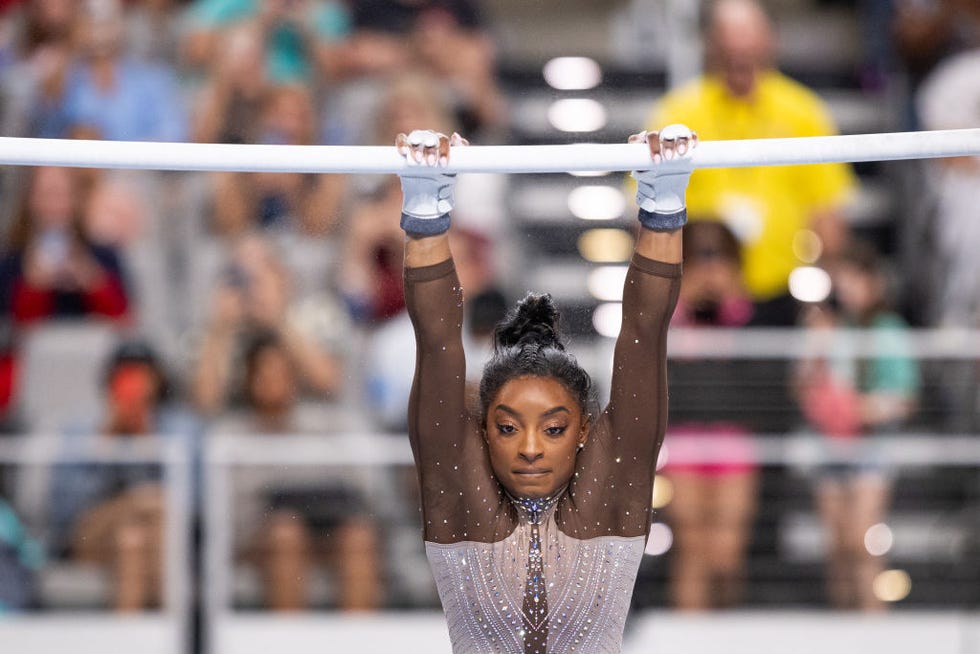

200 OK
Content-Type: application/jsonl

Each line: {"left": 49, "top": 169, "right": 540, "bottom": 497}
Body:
{"left": 629, "top": 125, "right": 698, "bottom": 232}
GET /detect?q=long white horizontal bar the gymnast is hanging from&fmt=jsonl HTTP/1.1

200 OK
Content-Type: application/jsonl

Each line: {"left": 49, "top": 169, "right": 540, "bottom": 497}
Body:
{"left": 0, "top": 129, "right": 980, "bottom": 173}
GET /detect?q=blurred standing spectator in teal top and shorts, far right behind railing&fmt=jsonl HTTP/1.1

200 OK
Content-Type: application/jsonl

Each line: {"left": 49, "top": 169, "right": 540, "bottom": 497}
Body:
{"left": 796, "top": 242, "right": 920, "bottom": 610}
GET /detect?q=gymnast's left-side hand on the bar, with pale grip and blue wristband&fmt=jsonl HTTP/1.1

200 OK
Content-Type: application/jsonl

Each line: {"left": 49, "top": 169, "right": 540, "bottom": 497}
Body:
{"left": 395, "top": 130, "right": 469, "bottom": 237}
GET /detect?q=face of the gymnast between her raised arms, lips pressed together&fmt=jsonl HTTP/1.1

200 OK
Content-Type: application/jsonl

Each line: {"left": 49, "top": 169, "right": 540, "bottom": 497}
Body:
{"left": 486, "top": 377, "right": 589, "bottom": 498}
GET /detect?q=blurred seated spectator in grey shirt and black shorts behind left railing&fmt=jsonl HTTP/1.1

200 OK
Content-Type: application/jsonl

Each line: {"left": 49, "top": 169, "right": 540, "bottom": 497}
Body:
{"left": 215, "top": 332, "right": 382, "bottom": 611}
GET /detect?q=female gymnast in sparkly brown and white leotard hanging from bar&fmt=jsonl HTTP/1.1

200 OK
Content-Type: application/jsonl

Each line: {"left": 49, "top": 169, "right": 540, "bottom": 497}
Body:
{"left": 397, "top": 125, "right": 697, "bottom": 654}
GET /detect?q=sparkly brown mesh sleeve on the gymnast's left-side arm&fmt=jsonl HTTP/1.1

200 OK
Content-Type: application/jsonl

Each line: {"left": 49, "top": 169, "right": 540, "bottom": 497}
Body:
{"left": 405, "top": 259, "right": 513, "bottom": 543}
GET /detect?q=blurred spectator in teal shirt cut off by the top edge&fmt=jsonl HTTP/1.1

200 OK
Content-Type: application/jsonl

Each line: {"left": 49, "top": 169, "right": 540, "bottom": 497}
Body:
{"left": 183, "top": 0, "right": 350, "bottom": 84}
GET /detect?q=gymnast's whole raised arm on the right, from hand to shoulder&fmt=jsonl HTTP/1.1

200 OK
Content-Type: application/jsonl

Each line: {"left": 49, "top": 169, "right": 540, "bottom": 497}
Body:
{"left": 579, "top": 125, "right": 697, "bottom": 536}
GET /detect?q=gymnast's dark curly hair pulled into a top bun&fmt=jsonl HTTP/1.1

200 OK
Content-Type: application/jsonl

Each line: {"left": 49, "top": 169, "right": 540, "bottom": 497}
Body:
{"left": 480, "top": 293, "right": 598, "bottom": 424}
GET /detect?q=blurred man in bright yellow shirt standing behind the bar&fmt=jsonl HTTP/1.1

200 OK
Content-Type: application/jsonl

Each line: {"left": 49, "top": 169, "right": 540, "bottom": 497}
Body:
{"left": 649, "top": 0, "right": 857, "bottom": 301}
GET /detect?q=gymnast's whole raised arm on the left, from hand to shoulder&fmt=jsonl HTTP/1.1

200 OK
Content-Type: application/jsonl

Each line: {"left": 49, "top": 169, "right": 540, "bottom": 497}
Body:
{"left": 398, "top": 132, "right": 493, "bottom": 542}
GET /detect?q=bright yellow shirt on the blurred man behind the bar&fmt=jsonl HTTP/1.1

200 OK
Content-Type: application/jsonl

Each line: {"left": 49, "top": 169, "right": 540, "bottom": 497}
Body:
{"left": 648, "top": 71, "right": 857, "bottom": 300}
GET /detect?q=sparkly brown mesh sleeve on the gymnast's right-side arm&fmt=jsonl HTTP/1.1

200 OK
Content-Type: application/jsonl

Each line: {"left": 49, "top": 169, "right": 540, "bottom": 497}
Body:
{"left": 563, "top": 254, "right": 681, "bottom": 538}
